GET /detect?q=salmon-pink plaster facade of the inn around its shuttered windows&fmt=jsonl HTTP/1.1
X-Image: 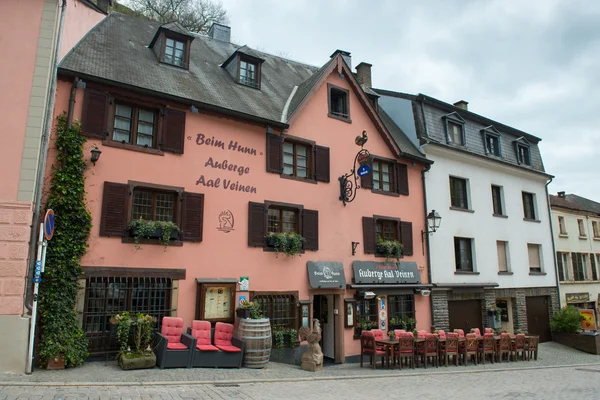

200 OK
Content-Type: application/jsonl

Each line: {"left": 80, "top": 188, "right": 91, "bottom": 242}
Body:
{"left": 49, "top": 68, "right": 431, "bottom": 355}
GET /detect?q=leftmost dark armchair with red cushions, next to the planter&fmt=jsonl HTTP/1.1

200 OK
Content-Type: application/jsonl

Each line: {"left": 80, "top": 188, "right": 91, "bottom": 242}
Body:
{"left": 156, "top": 317, "right": 196, "bottom": 369}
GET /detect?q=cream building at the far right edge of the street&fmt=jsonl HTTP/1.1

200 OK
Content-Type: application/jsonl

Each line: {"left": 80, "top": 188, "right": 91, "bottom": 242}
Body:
{"left": 550, "top": 192, "right": 600, "bottom": 326}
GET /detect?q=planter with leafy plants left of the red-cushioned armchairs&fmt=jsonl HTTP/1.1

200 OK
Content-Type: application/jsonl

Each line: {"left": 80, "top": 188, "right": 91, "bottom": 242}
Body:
{"left": 110, "top": 311, "right": 156, "bottom": 370}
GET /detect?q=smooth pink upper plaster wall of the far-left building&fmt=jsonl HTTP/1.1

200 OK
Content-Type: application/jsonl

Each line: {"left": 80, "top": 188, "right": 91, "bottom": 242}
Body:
{"left": 0, "top": 0, "right": 44, "bottom": 201}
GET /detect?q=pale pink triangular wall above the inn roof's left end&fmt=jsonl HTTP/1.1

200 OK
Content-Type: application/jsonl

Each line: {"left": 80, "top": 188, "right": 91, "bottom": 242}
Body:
{"left": 59, "top": 0, "right": 106, "bottom": 60}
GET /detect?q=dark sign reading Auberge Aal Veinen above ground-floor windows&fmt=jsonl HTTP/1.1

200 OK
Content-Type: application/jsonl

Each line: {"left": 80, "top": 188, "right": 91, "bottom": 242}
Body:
{"left": 352, "top": 261, "right": 421, "bottom": 284}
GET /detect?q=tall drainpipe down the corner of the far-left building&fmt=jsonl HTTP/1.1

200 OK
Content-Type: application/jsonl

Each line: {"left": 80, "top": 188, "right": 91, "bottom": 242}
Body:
{"left": 25, "top": 0, "right": 67, "bottom": 311}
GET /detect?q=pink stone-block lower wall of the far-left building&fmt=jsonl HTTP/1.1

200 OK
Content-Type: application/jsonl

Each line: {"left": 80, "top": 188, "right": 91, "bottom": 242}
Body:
{"left": 0, "top": 202, "right": 32, "bottom": 315}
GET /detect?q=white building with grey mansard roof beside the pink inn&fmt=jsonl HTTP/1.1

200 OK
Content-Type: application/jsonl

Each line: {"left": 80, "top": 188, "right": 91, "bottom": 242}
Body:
{"left": 375, "top": 89, "right": 558, "bottom": 341}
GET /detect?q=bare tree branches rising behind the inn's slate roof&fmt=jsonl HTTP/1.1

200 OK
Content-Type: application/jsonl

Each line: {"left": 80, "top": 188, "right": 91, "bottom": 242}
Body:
{"left": 128, "top": 0, "right": 229, "bottom": 33}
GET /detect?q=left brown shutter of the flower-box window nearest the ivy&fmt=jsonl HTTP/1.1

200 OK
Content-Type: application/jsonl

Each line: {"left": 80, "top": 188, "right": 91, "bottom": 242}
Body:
{"left": 100, "top": 182, "right": 129, "bottom": 237}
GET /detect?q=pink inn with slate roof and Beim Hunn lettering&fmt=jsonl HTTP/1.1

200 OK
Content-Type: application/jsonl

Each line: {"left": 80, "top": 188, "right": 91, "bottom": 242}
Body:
{"left": 50, "top": 13, "right": 431, "bottom": 362}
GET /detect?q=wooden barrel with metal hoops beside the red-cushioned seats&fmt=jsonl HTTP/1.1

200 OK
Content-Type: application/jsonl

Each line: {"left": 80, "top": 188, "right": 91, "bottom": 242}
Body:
{"left": 237, "top": 318, "right": 272, "bottom": 368}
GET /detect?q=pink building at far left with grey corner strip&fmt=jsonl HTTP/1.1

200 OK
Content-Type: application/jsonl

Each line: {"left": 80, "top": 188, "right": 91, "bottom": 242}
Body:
{"left": 0, "top": 0, "right": 109, "bottom": 372}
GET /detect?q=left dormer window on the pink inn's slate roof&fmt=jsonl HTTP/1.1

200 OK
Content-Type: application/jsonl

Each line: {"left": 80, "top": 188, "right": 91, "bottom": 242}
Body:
{"left": 148, "top": 22, "right": 194, "bottom": 69}
